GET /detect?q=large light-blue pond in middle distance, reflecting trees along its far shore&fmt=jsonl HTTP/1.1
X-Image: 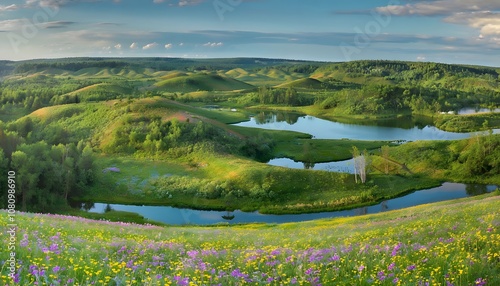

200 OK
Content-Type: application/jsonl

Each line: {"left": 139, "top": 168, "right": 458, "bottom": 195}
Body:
{"left": 235, "top": 111, "right": 500, "bottom": 141}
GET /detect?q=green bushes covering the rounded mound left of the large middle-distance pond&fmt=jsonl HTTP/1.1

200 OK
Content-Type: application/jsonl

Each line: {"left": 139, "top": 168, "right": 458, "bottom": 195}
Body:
{"left": 101, "top": 117, "right": 275, "bottom": 161}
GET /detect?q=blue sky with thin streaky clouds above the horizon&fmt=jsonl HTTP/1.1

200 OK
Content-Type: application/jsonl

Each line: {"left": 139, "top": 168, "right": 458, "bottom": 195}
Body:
{"left": 0, "top": 0, "right": 500, "bottom": 67}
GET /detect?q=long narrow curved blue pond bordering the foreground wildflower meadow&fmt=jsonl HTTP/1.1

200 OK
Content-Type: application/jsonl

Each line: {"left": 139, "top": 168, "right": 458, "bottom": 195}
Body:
{"left": 84, "top": 183, "right": 497, "bottom": 225}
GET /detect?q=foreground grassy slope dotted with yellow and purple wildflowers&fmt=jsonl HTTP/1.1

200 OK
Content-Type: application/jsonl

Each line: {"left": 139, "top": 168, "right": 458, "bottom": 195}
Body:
{"left": 0, "top": 195, "right": 500, "bottom": 285}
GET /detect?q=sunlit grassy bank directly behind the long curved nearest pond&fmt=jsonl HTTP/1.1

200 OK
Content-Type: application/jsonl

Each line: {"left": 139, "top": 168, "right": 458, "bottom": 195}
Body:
{"left": 80, "top": 153, "right": 439, "bottom": 214}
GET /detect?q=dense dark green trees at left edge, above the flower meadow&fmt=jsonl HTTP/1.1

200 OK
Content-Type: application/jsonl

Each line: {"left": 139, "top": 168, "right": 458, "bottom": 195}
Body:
{"left": 0, "top": 134, "right": 96, "bottom": 212}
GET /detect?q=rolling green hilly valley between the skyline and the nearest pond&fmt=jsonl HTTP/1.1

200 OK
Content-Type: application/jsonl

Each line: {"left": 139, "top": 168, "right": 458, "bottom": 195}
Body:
{"left": 0, "top": 58, "right": 500, "bottom": 215}
